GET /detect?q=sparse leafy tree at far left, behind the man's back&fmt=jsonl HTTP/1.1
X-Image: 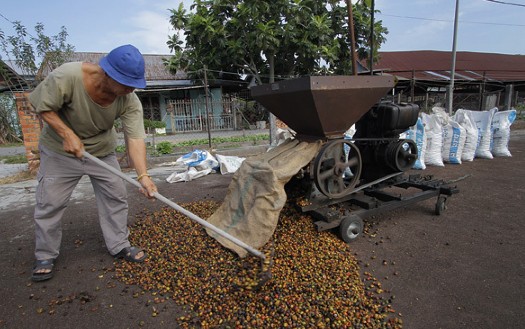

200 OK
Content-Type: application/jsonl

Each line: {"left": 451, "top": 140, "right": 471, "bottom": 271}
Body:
{"left": 0, "top": 21, "right": 74, "bottom": 143}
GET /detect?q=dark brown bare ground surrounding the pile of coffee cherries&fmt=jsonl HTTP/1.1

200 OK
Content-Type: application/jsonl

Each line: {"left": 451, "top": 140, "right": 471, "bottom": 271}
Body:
{"left": 0, "top": 129, "right": 525, "bottom": 329}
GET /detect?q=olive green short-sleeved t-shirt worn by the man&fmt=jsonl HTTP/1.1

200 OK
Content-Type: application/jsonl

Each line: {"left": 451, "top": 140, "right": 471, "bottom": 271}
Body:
{"left": 29, "top": 62, "right": 146, "bottom": 157}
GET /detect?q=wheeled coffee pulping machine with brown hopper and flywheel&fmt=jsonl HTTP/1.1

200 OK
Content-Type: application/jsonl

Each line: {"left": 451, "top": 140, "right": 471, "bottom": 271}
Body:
{"left": 251, "top": 75, "right": 458, "bottom": 242}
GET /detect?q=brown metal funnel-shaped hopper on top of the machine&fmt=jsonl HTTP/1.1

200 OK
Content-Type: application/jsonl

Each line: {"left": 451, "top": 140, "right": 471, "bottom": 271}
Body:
{"left": 251, "top": 75, "right": 395, "bottom": 138}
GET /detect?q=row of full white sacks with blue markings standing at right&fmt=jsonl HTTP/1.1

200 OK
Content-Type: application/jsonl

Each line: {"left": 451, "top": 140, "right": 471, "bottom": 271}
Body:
{"left": 400, "top": 107, "right": 516, "bottom": 170}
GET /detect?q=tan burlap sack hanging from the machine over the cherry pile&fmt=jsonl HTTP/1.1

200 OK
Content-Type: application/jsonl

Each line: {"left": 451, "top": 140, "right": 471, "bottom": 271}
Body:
{"left": 206, "top": 140, "right": 321, "bottom": 257}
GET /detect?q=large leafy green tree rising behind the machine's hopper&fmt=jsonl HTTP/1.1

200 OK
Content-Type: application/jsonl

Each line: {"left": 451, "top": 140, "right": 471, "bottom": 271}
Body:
{"left": 167, "top": 0, "right": 388, "bottom": 84}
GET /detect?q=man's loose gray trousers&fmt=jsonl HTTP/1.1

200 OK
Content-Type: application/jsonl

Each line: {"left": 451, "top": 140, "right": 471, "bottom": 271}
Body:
{"left": 35, "top": 145, "right": 130, "bottom": 260}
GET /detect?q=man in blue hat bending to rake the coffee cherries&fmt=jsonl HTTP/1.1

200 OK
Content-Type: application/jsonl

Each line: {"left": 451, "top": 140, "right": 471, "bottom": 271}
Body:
{"left": 29, "top": 45, "right": 157, "bottom": 281}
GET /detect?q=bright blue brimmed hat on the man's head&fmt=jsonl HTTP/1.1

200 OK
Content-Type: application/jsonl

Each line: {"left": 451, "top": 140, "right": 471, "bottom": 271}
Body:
{"left": 99, "top": 45, "right": 146, "bottom": 89}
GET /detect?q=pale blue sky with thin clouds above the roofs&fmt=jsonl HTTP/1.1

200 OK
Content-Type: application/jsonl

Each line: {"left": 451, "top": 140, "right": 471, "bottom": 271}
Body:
{"left": 0, "top": 0, "right": 525, "bottom": 58}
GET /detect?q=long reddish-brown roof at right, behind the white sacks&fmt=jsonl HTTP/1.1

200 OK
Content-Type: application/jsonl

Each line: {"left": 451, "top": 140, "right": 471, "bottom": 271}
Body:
{"left": 374, "top": 50, "right": 525, "bottom": 82}
